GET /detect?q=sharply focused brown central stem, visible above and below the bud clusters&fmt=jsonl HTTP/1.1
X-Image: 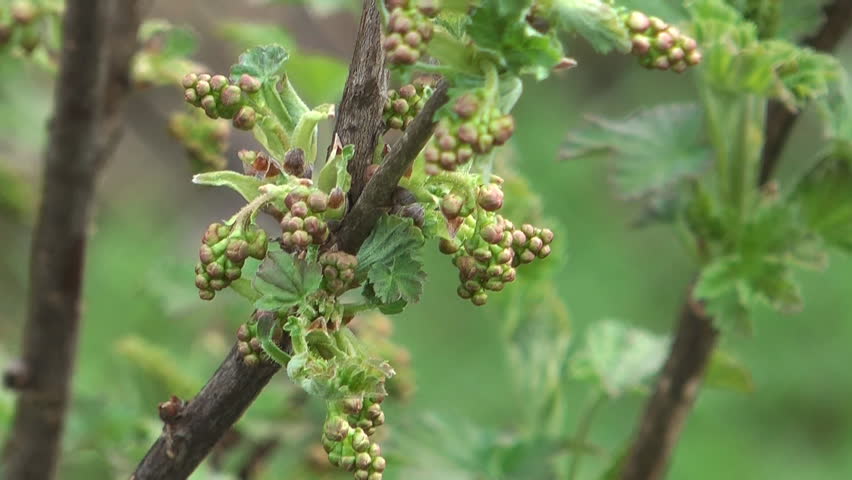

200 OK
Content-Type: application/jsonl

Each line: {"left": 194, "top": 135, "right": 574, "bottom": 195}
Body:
{"left": 132, "top": 0, "right": 434, "bottom": 480}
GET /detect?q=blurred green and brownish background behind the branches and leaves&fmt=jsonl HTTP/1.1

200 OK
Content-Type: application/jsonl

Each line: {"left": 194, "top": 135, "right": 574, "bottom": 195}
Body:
{"left": 0, "top": 0, "right": 852, "bottom": 480}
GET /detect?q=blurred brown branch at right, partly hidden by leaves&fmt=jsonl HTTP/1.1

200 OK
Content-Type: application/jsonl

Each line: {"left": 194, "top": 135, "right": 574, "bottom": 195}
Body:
{"left": 621, "top": 4, "right": 852, "bottom": 480}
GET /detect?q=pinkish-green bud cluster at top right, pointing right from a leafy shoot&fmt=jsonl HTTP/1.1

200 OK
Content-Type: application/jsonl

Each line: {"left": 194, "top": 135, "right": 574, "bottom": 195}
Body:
{"left": 624, "top": 11, "right": 701, "bottom": 73}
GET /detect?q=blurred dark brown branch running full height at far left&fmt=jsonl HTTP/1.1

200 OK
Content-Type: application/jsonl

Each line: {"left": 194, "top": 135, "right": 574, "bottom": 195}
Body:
{"left": 4, "top": 0, "right": 139, "bottom": 480}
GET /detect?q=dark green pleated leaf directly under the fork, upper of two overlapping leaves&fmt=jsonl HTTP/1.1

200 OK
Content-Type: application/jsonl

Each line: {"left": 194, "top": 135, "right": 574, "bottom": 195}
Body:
{"left": 357, "top": 215, "right": 426, "bottom": 278}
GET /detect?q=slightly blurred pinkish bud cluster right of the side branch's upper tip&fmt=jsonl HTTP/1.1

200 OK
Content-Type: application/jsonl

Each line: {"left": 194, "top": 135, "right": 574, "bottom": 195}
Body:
{"left": 423, "top": 91, "right": 515, "bottom": 175}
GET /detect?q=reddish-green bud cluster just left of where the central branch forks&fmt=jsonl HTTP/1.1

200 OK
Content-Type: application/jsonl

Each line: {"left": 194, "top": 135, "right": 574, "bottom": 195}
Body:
{"left": 281, "top": 188, "right": 344, "bottom": 253}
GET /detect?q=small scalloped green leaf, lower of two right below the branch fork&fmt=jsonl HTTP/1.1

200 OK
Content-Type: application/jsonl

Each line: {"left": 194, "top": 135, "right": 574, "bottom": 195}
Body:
{"left": 367, "top": 256, "right": 426, "bottom": 304}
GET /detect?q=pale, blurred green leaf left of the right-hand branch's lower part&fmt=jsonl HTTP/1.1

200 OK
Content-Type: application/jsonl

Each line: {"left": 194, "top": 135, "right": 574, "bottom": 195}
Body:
{"left": 571, "top": 320, "right": 669, "bottom": 398}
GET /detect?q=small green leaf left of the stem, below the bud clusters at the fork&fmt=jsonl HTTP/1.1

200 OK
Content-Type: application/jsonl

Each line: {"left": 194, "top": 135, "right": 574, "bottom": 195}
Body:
{"left": 254, "top": 248, "right": 322, "bottom": 312}
